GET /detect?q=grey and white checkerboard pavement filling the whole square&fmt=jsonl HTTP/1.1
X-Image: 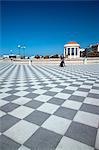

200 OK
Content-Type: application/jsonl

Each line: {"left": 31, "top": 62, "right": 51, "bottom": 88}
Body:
{"left": 0, "top": 63, "right": 99, "bottom": 150}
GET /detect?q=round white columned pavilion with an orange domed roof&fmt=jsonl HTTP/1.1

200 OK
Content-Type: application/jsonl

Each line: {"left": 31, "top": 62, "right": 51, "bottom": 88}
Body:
{"left": 64, "top": 41, "right": 80, "bottom": 59}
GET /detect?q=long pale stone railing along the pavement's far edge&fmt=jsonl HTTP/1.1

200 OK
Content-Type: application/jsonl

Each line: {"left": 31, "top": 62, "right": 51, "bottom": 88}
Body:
{"left": 2, "top": 57, "right": 99, "bottom": 64}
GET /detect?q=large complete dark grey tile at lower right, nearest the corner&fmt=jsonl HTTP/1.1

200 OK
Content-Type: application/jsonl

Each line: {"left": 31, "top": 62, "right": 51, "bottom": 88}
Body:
{"left": 65, "top": 122, "right": 97, "bottom": 147}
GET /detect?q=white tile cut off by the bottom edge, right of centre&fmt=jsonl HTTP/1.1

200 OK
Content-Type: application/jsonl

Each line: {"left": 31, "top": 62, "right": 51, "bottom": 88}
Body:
{"left": 56, "top": 136, "right": 94, "bottom": 150}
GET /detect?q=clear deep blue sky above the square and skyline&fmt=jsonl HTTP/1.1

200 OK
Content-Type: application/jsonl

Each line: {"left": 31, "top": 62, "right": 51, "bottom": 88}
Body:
{"left": 0, "top": 1, "right": 99, "bottom": 55}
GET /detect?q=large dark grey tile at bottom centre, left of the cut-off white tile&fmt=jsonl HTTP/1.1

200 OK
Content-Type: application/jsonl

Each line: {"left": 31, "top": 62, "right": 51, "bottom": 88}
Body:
{"left": 24, "top": 128, "right": 62, "bottom": 150}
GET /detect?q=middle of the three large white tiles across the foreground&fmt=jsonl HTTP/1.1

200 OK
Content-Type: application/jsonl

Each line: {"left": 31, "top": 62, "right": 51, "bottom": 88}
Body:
{"left": 42, "top": 115, "right": 71, "bottom": 135}
